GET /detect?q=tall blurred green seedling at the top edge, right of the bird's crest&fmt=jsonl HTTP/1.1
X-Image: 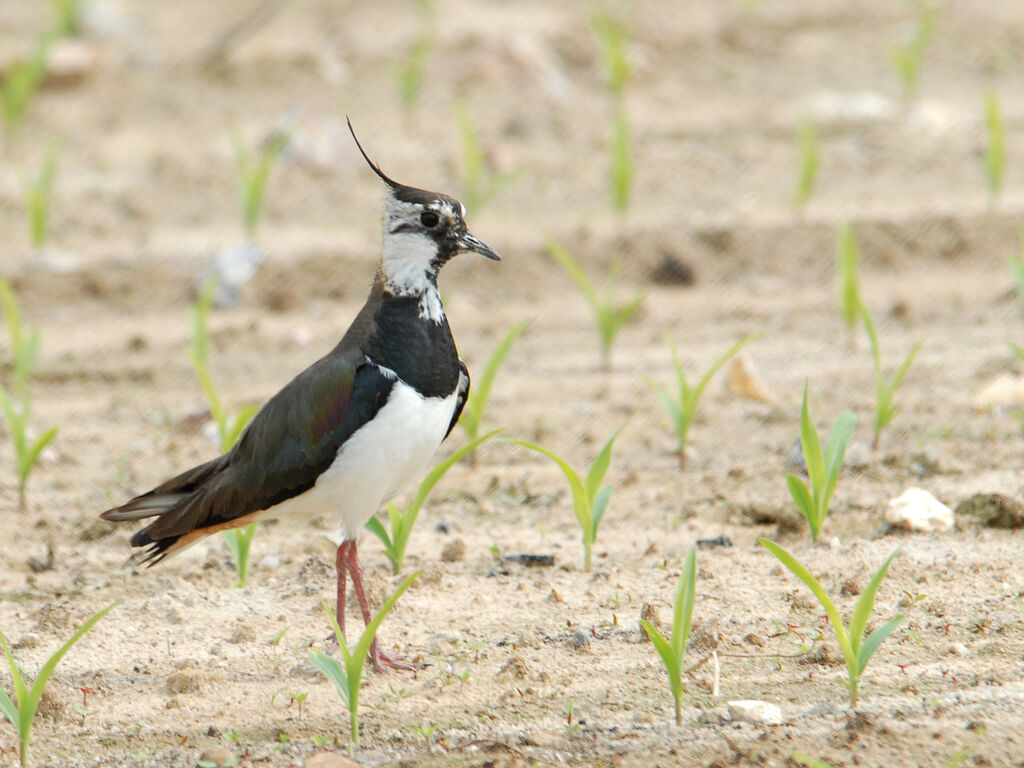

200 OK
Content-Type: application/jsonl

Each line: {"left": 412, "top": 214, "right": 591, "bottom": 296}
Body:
{"left": 591, "top": 7, "right": 633, "bottom": 211}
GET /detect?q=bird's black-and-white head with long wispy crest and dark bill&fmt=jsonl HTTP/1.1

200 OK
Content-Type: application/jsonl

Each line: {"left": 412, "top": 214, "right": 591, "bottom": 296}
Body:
{"left": 348, "top": 122, "right": 501, "bottom": 301}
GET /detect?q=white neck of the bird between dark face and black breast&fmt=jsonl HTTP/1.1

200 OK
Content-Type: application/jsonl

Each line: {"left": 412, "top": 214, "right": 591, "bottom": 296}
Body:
{"left": 378, "top": 232, "right": 444, "bottom": 323}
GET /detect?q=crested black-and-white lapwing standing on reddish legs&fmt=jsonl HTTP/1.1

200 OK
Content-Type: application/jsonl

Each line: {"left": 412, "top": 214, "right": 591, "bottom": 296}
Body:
{"left": 99, "top": 120, "right": 501, "bottom": 671}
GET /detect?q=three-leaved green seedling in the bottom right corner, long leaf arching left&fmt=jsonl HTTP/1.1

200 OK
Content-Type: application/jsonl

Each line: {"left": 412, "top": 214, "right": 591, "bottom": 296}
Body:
{"left": 758, "top": 539, "right": 903, "bottom": 709}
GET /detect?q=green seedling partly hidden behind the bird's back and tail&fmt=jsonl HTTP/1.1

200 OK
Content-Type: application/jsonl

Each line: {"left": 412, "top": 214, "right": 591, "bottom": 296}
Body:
{"left": 185, "top": 281, "right": 259, "bottom": 589}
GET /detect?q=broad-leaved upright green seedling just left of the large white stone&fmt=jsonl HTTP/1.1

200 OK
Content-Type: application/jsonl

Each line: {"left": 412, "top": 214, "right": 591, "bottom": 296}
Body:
{"left": 785, "top": 384, "right": 857, "bottom": 541}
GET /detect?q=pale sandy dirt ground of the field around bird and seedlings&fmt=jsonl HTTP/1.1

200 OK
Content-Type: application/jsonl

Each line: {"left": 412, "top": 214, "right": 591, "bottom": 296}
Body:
{"left": 0, "top": 0, "right": 1024, "bottom": 768}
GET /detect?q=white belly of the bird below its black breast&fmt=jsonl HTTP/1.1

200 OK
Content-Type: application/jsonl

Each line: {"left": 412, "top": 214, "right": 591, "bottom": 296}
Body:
{"left": 266, "top": 381, "right": 458, "bottom": 539}
